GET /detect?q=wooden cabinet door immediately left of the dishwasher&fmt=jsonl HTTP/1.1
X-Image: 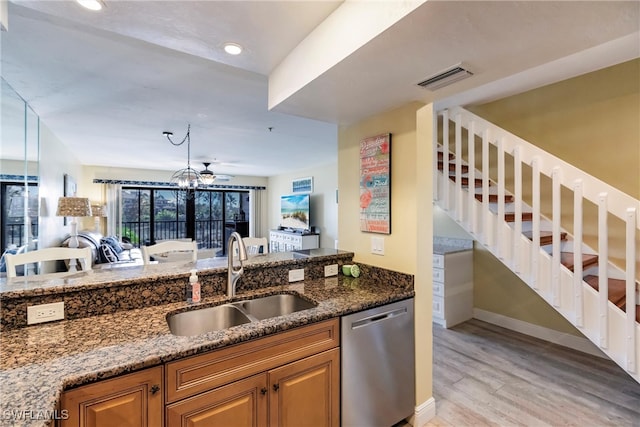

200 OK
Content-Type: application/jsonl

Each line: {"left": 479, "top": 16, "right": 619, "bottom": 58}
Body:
{"left": 269, "top": 348, "right": 340, "bottom": 427}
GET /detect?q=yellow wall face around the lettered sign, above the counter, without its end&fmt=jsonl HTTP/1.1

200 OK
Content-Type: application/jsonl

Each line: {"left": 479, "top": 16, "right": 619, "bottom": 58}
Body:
{"left": 338, "top": 103, "right": 422, "bottom": 274}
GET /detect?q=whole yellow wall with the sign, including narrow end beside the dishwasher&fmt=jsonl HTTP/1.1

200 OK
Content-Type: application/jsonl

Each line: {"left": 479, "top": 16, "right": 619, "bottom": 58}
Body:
{"left": 338, "top": 102, "right": 433, "bottom": 405}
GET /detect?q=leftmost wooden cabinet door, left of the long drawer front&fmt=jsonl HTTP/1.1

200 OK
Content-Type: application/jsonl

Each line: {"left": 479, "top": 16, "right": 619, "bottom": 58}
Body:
{"left": 60, "top": 366, "right": 164, "bottom": 427}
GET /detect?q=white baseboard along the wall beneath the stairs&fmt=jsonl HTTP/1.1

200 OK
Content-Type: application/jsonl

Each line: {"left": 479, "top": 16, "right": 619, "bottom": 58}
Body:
{"left": 473, "top": 308, "right": 609, "bottom": 359}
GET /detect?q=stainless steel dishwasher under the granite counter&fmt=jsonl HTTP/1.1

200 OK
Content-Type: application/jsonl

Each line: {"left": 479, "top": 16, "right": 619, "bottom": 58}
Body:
{"left": 341, "top": 298, "right": 415, "bottom": 427}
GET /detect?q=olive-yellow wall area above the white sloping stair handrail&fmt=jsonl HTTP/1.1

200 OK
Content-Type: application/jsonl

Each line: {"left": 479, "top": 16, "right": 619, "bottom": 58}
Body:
{"left": 467, "top": 59, "right": 640, "bottom": 199}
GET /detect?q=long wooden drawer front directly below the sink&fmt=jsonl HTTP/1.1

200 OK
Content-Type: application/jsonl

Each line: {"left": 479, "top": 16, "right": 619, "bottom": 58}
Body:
{"left": 165, "top": 319, "right": 340, "bottom": 403}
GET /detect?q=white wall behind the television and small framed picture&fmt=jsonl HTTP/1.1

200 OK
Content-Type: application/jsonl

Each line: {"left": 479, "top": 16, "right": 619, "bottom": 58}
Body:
{"left": 268, "top": 162, "right": 338, "bottom": 248}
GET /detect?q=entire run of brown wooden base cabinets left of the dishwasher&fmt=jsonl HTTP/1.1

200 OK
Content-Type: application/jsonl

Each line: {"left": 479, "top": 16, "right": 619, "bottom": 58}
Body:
{"left": 60, "top": 319, "right": 340, "bottom": 427}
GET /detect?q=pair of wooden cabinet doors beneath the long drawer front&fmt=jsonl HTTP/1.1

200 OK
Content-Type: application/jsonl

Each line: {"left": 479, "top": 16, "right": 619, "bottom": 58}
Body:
{"left": 167, "top": 348, "right": 340, "bottom": 427}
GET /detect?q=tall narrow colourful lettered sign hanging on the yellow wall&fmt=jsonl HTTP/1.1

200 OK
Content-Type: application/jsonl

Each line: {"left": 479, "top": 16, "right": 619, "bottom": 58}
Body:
{"left": 360, "top": 133, "right": 391, "bottom": 234}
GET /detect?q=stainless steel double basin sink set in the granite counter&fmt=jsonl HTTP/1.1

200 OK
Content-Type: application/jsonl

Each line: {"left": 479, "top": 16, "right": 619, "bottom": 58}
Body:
{"left": 167, "top": 294, "right": 318, "bottom": 336}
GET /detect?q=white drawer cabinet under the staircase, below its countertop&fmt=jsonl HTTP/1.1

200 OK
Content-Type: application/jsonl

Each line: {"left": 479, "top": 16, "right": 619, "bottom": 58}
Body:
{"left": 433, "top": 250, "right": 473, "bottom": 328}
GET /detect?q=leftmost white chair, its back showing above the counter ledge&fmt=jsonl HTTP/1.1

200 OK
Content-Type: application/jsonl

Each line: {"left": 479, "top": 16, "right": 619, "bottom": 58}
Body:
{"left": 5, "top": 247, "right": 93, "bottom": 278}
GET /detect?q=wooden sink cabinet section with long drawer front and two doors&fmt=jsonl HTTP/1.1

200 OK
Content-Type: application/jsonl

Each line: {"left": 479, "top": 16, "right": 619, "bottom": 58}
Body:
{"left": 165, "top": 319, "right": 340, "bottom": 427}
